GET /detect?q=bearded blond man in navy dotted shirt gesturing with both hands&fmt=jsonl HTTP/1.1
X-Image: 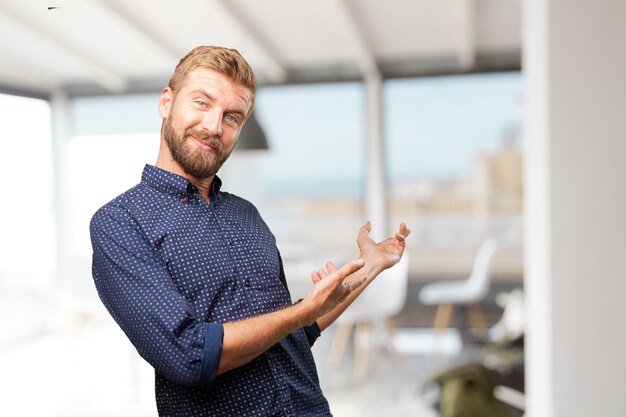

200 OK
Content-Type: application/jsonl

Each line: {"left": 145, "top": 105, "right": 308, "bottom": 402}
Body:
{"left": 91, "top": 46, "right": 410, "bottom": 417}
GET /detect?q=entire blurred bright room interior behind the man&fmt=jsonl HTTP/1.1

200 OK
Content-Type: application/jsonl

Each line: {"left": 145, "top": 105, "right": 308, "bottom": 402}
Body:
{"left": 0, "top": 0, "right": 626, "bottom": 417}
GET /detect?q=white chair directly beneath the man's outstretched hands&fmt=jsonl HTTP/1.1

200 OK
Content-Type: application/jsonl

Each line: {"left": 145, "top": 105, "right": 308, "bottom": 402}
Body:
{"left": 328, "top": 251, "right": 409, "bottom": 379}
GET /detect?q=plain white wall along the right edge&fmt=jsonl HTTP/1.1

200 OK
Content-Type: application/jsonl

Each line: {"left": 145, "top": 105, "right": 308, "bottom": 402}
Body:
{"left": 524, "top": 0, "right": 626, "bottom": 417}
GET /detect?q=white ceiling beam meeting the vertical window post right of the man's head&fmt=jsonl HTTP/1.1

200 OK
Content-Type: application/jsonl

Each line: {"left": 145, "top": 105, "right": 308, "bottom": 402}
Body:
{"left": 328, "top": 0, "right": 381, "bottom": 78}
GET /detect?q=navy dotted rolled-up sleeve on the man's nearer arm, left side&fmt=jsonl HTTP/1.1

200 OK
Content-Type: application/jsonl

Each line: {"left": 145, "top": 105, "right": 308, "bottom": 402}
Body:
{"left": 90, "top": 205, "right": 224, "bottom": 385}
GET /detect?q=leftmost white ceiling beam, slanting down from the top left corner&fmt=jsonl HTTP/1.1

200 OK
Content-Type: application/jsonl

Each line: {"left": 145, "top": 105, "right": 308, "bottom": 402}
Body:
{"left": 0, "top": 3, "right": 127, "bottom": 93}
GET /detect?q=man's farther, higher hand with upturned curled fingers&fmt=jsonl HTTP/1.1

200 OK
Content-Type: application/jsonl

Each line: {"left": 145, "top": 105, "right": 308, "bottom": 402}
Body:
{"left": 356, "top": 221, "right": 411, "bottom": 269}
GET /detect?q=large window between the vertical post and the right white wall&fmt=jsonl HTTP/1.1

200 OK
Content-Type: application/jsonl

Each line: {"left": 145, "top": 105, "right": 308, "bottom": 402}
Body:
{"left": 385, "top": 72, "right": 523, "bottom": 278}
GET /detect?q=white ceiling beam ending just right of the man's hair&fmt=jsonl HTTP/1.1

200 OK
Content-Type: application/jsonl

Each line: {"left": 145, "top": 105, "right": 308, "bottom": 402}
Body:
{"left": 211, "top": 0, "right": 288, "bottom": 83}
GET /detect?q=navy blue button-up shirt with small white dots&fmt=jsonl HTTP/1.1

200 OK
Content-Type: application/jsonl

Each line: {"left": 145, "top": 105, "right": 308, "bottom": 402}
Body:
{"left": 91, "top": 165, "right": 331, "bottom": 417}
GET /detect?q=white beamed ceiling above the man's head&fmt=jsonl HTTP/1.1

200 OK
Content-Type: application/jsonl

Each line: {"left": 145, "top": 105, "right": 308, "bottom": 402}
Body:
{"left": 0, "top": 0, "right": 521, "bottom": 94}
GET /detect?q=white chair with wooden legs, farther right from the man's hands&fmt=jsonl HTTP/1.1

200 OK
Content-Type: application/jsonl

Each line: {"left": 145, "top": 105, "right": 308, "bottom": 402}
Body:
{"left": 419, "top": 239, "right": 498, "bottom": 332}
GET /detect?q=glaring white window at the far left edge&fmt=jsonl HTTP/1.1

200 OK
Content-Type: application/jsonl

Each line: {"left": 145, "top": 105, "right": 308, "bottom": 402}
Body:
{"left": 0, "top": 94, "right": 55, "bottom": 290}
